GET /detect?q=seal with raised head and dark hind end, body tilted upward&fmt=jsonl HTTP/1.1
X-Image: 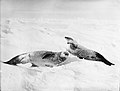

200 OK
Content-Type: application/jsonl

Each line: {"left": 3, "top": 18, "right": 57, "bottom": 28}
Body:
{"left": 65, "top": 37, "right": 114, "bottom": 66}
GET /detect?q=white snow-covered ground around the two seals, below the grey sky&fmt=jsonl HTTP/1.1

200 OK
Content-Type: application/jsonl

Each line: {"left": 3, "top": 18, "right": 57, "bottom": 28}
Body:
{"left": 1, "top": 18, "right": 120, "bottom": 91}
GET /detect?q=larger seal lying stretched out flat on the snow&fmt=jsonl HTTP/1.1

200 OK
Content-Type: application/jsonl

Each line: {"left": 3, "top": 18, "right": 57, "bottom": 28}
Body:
{"left": 3, "top": 51, "right": 69, "bottom": 67}
